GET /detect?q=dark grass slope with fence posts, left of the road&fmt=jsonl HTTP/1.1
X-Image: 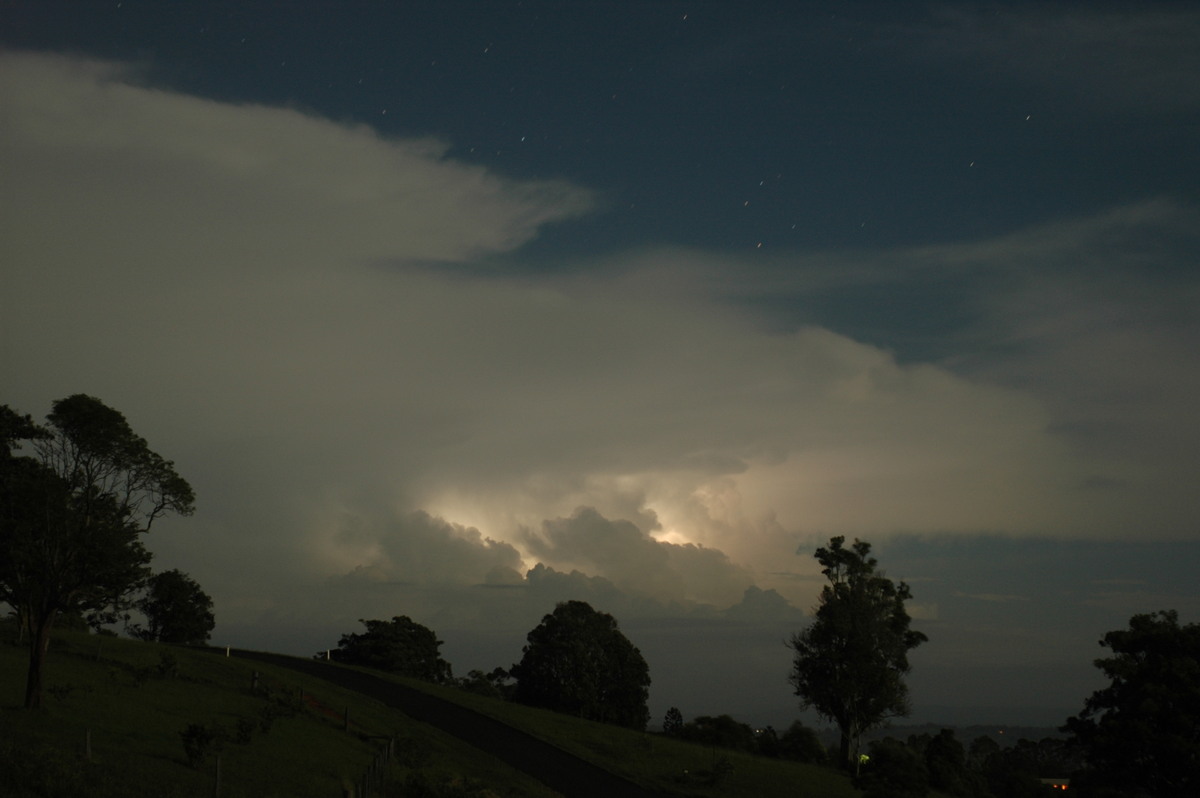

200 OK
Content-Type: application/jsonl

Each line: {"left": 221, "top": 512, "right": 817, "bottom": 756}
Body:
{"left": 0, "top": 629, "right": 553, "bottom": 798}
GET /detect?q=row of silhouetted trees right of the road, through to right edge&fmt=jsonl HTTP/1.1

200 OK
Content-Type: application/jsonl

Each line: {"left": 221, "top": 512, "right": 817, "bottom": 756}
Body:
{"left": 322, "top": 538, "right": 1200, "bottom": 798}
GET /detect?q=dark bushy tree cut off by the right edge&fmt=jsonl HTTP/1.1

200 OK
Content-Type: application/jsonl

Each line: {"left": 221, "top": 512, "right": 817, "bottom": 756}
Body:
{"left": 1063, "top": 610, "right": 1200, "bottom": 798}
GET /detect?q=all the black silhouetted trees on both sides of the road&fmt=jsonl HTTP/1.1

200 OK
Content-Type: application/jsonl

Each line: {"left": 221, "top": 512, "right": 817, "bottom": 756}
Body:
{"left": 0, "top": 394, "right": 1200, "bottom": 798}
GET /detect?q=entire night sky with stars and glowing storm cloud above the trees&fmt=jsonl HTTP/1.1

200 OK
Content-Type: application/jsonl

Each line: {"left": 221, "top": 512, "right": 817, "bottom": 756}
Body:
{"left": 0, "top": 0, "right": 1200, "bottom": 727}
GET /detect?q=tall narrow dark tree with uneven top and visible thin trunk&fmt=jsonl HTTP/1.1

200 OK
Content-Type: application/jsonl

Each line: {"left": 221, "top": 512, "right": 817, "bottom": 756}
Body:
{"left": 790, "top": 536, "right": 928, "bottom": 767}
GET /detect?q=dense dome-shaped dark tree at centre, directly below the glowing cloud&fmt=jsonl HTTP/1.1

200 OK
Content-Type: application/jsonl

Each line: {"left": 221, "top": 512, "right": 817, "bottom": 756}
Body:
{"left": 510, "top": 601, "right": 650, "bottom": 730}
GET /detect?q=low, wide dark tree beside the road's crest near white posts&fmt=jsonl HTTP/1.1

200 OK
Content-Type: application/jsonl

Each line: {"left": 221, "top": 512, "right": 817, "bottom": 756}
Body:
{"left": 330, "top": 616, "right": 452, "bottom": 683}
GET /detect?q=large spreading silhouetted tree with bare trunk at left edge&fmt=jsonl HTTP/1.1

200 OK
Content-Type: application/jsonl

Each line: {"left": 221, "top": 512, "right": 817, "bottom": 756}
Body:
{"left": 0, "top": 394, "right": 194, "bottom": 708}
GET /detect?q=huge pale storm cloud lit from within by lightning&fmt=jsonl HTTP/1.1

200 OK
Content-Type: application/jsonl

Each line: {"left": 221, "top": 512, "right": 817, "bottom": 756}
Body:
{"left": 0, "top": 54, "right": 1194, "bottom": 652}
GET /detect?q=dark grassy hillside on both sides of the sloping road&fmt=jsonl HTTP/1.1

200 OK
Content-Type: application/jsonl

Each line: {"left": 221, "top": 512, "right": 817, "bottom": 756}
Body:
{"left": 0, "top": 626, "right": 858, "bottom": 798}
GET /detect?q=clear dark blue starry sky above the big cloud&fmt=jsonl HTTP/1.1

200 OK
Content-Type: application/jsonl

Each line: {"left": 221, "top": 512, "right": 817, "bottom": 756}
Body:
{"left": 14, "top": 1, "right": 1200, "bottom": 257}
